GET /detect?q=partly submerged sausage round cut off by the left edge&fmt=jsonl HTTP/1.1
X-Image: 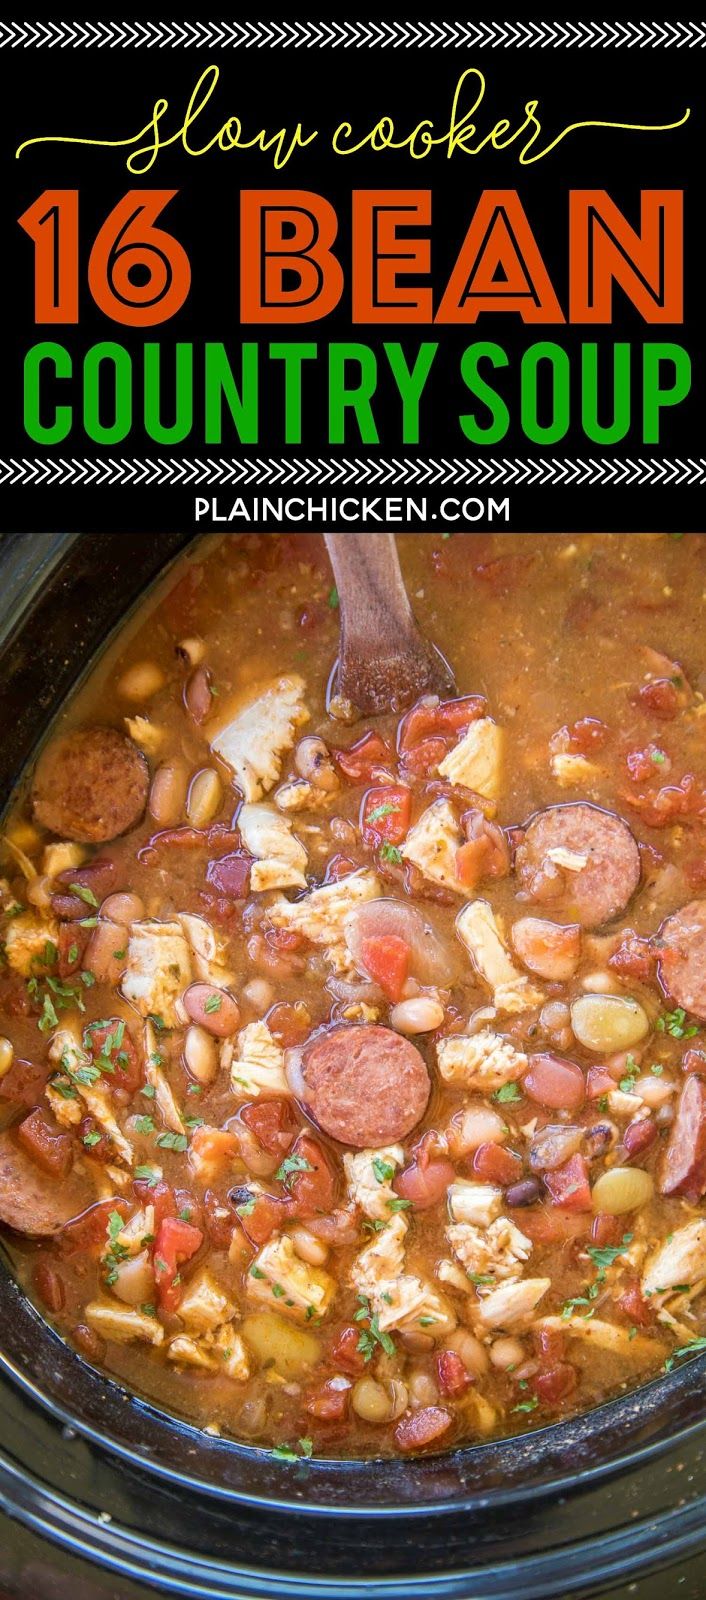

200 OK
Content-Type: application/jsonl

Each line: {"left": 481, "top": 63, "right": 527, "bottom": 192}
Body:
{"left": 0, "top": 1130, "right": 94, "bottom": 1238}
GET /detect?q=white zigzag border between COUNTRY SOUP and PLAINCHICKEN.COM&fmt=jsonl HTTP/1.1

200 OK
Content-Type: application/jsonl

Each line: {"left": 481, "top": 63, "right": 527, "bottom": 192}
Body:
{"left": 0, "top": 456, "right": 706, "bottom": 490}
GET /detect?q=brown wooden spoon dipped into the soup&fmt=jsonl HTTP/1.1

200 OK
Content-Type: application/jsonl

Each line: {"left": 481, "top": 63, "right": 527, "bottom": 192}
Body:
{"left": 325, "top": 533, "right": 455, "bottom": 712}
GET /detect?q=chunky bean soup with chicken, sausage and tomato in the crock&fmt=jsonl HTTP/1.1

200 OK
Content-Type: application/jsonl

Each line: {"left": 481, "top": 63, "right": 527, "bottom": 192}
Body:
{"left": 0, "top": 534, "right": 706, "bottom": 1459}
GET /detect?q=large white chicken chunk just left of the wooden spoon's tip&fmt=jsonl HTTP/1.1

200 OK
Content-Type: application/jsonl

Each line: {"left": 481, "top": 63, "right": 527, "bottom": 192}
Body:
{"left": 211, "top": 674, "right": 309, "bottom": 802}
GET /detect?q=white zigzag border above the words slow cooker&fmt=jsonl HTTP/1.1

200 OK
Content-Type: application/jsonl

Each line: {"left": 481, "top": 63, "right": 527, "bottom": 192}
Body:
{"left": 0, "top": 21, "right": 706, "bottom": 50}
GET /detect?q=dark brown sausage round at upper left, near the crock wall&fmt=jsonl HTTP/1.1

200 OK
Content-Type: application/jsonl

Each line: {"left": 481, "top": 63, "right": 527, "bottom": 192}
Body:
{"left": 32, "top": 728, "right": 149, "bottom": 845}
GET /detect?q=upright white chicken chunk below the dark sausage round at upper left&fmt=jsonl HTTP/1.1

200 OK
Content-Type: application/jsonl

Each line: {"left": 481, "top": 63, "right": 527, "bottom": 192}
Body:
{"left": 122, "top": 922, "right": 194, "bottom": 1027}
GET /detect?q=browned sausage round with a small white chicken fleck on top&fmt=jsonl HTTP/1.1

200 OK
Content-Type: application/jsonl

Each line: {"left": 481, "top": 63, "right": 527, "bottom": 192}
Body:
{"left": 515, "top": 802, "right": 640, "bottom": 928}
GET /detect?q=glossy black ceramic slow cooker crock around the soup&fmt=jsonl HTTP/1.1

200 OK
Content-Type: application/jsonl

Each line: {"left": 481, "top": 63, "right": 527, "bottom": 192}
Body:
{"left": 0, "top": 534, "right": 706, "bottom": 1600}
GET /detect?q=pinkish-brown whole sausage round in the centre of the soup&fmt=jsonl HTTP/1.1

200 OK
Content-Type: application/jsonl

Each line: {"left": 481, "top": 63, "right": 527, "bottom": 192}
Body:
{"left": 303, "top": 1026, "right": 431, "bottom": 1149}
